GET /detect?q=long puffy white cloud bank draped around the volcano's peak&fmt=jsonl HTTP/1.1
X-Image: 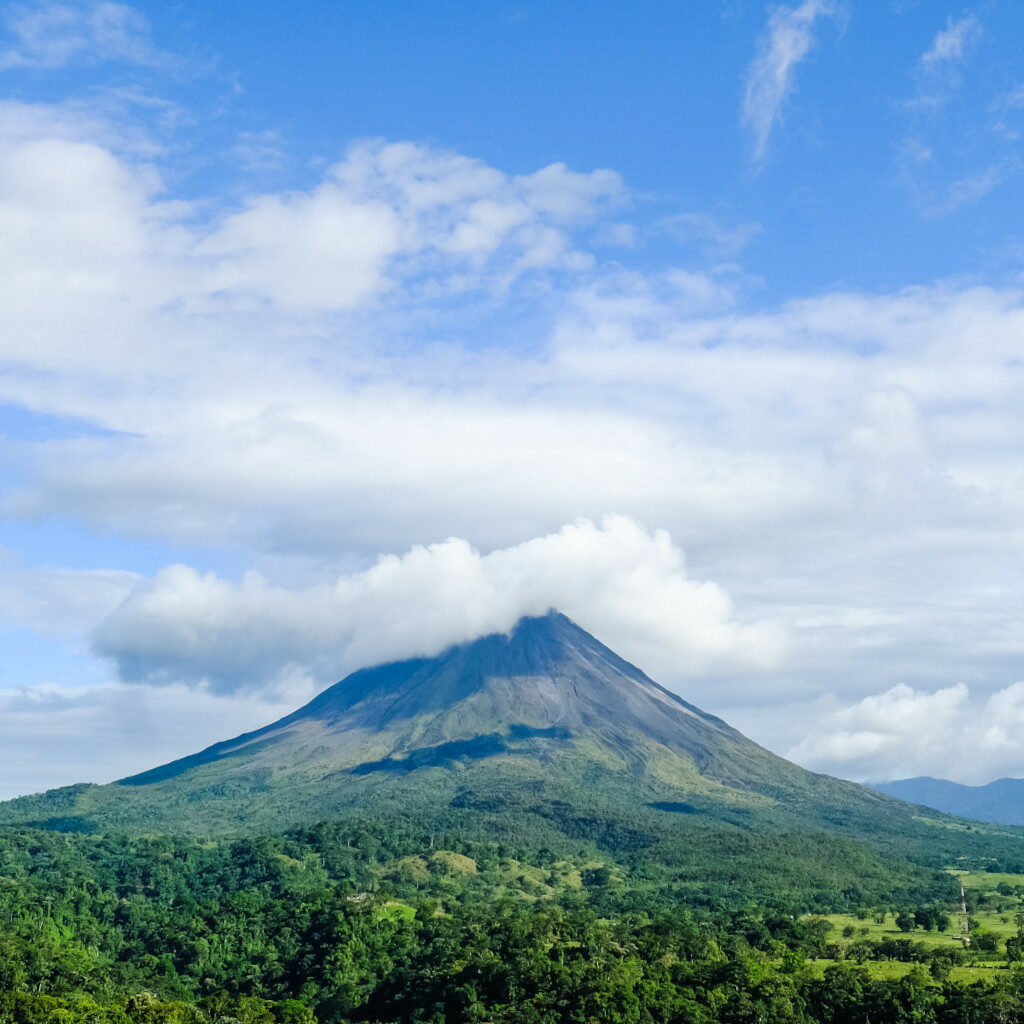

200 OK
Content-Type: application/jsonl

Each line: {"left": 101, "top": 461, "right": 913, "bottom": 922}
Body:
{"left": 94, "top": 516, "right": 784, "bottom": 694}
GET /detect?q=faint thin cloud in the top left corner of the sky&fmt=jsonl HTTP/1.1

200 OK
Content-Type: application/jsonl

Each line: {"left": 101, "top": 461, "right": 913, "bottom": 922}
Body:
{"left": 0, "top": 0, "right": 159, "bottom": 71}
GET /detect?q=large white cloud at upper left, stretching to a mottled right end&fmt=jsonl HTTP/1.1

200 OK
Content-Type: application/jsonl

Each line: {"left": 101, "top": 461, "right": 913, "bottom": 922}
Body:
{"left": 0, "top": 127, "right": 626, "bottom": 366}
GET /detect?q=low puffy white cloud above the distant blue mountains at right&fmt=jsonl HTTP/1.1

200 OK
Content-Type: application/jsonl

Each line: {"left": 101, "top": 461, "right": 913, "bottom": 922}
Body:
{"left": 787, "top": 682, "right": 1024, "bottom": 784}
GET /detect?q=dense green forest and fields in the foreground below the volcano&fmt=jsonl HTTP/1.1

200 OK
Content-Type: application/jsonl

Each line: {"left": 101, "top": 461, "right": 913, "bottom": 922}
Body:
{"left": 6, "top": 820, "right": 1024, "bottom": 1024}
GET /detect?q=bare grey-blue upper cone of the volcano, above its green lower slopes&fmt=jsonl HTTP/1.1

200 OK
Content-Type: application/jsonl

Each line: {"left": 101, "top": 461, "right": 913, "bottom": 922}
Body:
{"left": 123, "top": 611, "right": 753, "bottom": 785}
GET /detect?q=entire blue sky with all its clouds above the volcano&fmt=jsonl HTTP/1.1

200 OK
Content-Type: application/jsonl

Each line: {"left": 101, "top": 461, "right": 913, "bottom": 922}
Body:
{"left": 0, "top": 0, "right": 1024, "bottom": 795}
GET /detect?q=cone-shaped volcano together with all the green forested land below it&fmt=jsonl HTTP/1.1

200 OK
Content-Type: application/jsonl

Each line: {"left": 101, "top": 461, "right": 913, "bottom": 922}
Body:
{"left": 6, "top": 613, "right": 1024, "bottom": 1024}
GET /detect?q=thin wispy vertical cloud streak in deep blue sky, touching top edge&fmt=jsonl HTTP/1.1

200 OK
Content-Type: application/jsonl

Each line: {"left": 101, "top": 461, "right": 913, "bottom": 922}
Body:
{"left": 742, "top": 0, "right": 836, "bottom": 161}
